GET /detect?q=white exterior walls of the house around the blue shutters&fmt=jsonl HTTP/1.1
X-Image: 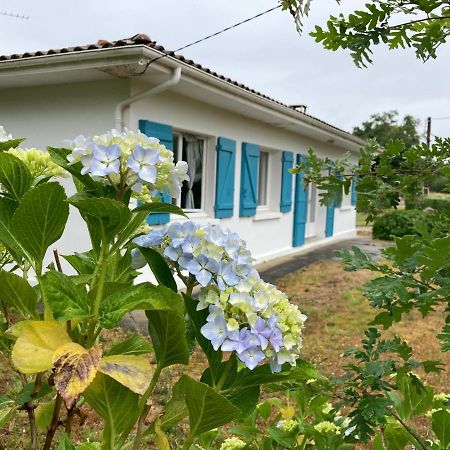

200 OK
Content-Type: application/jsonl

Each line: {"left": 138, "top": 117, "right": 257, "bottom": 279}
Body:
{"left": 0, "top": 80, "right": 356, "bottom": 266}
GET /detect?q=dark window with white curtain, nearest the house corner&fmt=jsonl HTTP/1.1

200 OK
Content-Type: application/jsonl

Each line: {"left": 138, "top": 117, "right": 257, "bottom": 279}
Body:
{"left": 173, "top": 133, "right": 205, "bottom": 211}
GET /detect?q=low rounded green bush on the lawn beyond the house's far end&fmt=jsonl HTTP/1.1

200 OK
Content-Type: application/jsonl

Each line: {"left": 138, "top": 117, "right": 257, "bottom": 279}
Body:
{"left": 372, "top": 209, "right": 428, "bottom": 241}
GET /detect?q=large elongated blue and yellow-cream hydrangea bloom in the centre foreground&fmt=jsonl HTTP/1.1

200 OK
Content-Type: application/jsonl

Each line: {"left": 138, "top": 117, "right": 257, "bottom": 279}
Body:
{"left": 133, "top": 221, "right": 306, "bottom": 372}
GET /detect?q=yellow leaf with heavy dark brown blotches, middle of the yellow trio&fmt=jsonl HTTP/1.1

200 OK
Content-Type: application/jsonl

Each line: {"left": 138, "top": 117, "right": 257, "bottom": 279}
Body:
{"left": 53, "top": 342, "right": 102, "bottom": 408}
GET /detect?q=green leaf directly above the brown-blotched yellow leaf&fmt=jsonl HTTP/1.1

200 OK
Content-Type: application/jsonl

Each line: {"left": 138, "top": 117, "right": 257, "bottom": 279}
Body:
{"left": 40, "top": 270, "right": 89, "bottom": 320}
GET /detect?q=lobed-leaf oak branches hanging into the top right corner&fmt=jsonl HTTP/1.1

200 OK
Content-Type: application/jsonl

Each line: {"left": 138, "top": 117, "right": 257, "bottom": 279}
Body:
{"left": 280, "top": 0, "right": 450, "bottom": 67}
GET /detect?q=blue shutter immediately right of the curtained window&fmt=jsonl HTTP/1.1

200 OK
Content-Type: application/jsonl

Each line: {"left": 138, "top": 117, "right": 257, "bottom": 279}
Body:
{"left": 214, "top": 137, "right": 236, "bottom": 219}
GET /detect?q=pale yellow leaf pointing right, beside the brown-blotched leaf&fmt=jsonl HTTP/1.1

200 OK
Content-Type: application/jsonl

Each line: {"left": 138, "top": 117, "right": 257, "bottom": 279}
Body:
{"left": 98, "top": 355, "right": 154, "bottom": 395}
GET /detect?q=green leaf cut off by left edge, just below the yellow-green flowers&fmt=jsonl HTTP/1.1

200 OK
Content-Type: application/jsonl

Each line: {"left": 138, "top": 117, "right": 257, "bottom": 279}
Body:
{"left": 0, "top": 152, "right": 33, "bottom": 200}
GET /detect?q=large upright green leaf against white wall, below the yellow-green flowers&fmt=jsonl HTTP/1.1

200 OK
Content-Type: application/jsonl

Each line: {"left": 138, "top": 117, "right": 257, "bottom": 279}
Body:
{"left": 12, "top": 183, "right": 69, "bottom": 264}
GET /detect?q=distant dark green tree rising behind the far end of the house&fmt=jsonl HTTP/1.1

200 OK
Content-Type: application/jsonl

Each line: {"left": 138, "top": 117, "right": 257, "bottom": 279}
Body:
{"left": 353, "top": 111, "right": 420, "bottom": 147}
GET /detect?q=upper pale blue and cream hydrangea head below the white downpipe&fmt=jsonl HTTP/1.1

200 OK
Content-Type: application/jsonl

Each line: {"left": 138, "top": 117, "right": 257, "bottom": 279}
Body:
{"left": 66, "top": 129, "right": 189, "bottom": 201}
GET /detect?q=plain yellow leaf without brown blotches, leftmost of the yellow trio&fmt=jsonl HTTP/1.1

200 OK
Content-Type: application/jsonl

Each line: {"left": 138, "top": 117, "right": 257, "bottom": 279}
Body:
{"left": 12, "top": 321, "right": 71, "bottom": 373}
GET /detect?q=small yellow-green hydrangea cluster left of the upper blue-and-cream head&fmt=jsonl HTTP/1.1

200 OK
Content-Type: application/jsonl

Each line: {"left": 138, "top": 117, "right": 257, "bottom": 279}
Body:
{"left": 8, "top": 148, "right": 67, "bottom": 180}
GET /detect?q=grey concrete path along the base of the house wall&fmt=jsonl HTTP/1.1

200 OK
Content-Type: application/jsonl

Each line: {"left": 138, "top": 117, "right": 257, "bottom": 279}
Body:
{"left": 121, "top": 235, "right": 386, "bottom": 335}
